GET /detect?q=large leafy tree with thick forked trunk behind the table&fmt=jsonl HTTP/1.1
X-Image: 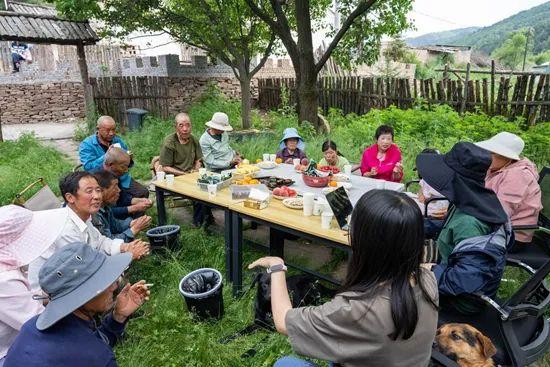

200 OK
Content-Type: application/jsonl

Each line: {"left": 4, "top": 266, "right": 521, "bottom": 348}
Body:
{"left": 245, "top": 0, "right": 412, "bottom": 127}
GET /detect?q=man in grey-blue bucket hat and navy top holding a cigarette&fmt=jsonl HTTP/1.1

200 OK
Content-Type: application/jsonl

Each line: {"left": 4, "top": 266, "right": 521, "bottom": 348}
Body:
{"left": 4, "top": 243, "right": 149, "bottom": 367}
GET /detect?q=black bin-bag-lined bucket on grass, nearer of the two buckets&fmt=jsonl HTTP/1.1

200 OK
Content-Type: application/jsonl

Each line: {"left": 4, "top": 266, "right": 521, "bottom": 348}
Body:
{"left": 179, "top": 268, "right": 224, "bottom": 320}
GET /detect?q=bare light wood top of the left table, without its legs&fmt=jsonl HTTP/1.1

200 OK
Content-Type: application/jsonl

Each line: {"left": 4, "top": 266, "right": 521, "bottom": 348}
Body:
{"left": 153, "top": 172, "right": 234, "bottom": 208}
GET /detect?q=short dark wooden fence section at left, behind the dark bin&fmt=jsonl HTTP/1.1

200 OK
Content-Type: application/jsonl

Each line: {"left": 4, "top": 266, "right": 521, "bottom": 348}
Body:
{"left": 91, "top": 76, "right": 169, "bottom": 126}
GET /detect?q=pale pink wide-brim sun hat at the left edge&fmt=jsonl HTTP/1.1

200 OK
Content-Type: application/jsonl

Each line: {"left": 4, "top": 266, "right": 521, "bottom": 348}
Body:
{"left": 0, "top": 205, "right": 69, "bottom": 272}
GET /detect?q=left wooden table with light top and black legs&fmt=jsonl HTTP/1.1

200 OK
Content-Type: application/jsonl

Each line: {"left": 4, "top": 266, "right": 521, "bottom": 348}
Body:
{"left": 153, "top": 172, "right": 233, "bottom": 281}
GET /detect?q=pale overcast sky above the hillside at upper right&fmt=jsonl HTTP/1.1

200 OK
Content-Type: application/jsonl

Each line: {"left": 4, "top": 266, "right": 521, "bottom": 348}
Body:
{"left": 405, "top": 0, "right": 548, "bottom": 37}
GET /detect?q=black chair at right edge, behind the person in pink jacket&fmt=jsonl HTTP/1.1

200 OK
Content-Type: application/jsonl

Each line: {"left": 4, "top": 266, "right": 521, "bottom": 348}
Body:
{"left": 507, "top": 167, "right": 550, "bottom": 269}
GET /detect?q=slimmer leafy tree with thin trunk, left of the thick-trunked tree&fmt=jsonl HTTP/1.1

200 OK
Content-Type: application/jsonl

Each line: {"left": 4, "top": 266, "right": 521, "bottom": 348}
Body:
{"left": 55, "top": 0, "right": 276, "bottom": 128}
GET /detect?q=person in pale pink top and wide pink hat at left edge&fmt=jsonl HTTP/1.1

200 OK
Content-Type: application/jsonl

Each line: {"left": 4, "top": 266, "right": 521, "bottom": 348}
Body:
{"left": 0, "top": 205, "right": 68, "bottom": 366}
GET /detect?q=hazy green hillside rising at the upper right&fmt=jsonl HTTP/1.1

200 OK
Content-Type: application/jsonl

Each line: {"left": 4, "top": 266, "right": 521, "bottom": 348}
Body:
{"left": 406, "top": 1, "right": 550, "bottom": 54}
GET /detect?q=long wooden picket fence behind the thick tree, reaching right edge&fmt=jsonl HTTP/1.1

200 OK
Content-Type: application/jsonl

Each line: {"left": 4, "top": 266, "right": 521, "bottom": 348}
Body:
{"left": 258, "top": 74, "right": 550, "bottom": 125}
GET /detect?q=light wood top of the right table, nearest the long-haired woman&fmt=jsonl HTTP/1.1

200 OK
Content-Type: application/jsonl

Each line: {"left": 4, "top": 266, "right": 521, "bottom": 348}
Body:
{"left": 229, "top": 198, "right": 348, "bottom": 245}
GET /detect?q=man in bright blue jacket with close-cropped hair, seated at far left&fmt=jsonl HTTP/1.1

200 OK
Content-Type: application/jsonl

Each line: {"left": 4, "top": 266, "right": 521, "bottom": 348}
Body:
{"left": 78, "top": 116, "right": 149, "bottom": 198}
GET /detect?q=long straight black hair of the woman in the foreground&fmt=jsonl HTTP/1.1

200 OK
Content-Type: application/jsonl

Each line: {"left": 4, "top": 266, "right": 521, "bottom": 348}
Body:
{"left": 342, "top": 190, "right": 437, "bottom": 340}
